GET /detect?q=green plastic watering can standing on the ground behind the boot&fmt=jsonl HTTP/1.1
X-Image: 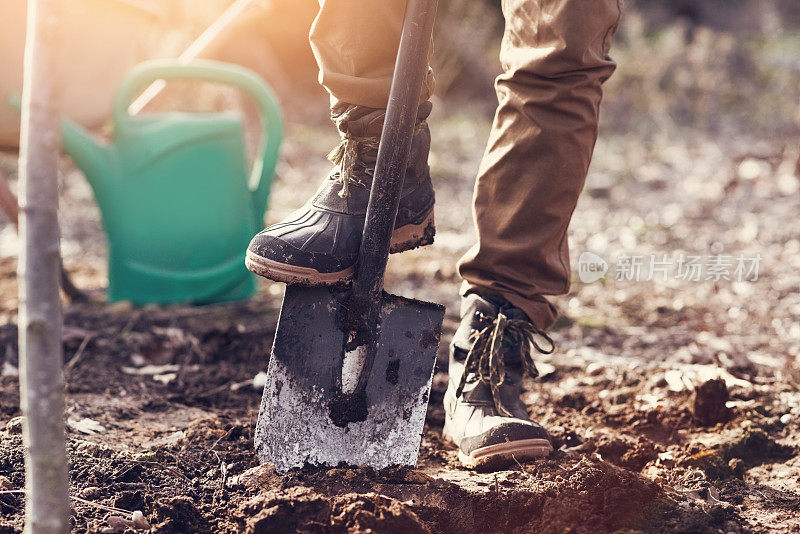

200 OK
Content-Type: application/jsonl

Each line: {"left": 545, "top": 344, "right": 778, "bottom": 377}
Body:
{"left": 63, "top": 60, "right": 282, "bottom": 304}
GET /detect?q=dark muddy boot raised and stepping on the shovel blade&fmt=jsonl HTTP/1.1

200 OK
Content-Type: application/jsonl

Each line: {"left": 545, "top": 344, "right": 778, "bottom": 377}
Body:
{"left": 245, "top": 102, "right": 435, "bottom": 285}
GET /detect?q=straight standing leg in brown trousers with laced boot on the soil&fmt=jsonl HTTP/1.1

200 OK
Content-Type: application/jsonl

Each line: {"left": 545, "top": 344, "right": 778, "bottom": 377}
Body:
{"left": 444, "top": 0, "right": 620, "bottom": 468}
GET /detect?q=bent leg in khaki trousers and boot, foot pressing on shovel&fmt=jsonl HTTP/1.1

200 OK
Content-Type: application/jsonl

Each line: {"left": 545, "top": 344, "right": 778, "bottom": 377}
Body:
{"left": 246, "top": 0, "right": 434, "bottom": 285}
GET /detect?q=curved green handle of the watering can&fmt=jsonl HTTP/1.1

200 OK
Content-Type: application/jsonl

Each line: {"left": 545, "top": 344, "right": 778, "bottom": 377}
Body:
{"left": 113, "top": 60, "right": 283, "bottom": 224}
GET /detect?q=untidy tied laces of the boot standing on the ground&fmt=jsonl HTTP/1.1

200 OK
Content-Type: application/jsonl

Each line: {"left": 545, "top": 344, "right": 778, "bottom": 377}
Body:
{"left": 456, "top": 311, "right": 555, "bottom": 417}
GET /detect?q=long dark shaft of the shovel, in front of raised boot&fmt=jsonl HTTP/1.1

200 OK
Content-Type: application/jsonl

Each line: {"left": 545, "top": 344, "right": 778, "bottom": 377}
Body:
{"left": 352, "top": 0, "right": 437, "bottom": 330}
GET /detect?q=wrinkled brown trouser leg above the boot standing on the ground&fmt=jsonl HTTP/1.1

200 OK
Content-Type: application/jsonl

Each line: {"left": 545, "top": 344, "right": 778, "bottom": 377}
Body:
{"left": 459, "top": 0, "right": 620, "bottom": 329}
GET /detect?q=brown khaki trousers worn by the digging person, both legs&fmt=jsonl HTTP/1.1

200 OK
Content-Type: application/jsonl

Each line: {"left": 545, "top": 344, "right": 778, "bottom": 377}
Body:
{"left": 310, "top": 0, "right": 621, "bottom": 328}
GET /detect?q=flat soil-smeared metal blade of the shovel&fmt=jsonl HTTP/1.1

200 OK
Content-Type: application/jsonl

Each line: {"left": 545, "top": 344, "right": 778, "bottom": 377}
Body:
{"left": 255, "top": 286, "right": 444, "bottom": 471}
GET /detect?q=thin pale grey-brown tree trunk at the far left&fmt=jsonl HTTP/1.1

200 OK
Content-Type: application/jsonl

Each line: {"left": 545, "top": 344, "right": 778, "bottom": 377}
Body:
{"left": 18, "top": 0, "right": 70, "bottom": 534}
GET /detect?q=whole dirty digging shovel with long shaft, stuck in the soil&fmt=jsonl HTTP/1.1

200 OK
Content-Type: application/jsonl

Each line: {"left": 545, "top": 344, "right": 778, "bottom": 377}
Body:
{"left": 255, "top": 0, "right": 444, "bottom": 471}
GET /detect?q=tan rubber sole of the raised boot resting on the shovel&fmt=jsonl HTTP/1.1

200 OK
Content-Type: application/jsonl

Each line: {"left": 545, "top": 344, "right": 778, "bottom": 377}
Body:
{"left": 244, "top": 210, "right": 436, "bottom": 286}
